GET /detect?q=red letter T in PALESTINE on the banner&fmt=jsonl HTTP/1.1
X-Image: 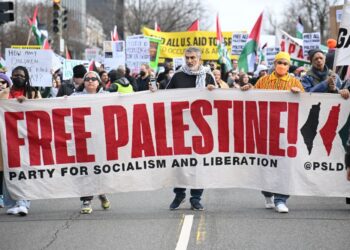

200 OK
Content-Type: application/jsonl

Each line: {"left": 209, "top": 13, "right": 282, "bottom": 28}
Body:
{"left": 214, "top": 101, "right": 232, "bottom": 153}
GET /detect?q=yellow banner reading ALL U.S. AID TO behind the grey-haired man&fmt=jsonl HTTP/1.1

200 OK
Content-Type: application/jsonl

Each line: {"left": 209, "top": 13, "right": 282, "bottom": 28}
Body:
{"left": 143, "top": 28, "right": 241, "bottom": 61}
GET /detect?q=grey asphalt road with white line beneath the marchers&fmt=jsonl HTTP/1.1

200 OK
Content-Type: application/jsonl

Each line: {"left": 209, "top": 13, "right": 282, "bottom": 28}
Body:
{"left": 0, "top": 189, "right": 350, "bottom": 250}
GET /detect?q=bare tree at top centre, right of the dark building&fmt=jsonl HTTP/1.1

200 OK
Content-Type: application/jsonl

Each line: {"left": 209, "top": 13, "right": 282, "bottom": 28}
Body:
{"left": 125, "top": 0, "right": 208, "bottom": 34}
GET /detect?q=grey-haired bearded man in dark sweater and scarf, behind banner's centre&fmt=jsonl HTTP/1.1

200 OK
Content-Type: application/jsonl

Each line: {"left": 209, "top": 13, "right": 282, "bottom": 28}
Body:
{"left": 165, "top": 47, "right": 216, "bottom": 210}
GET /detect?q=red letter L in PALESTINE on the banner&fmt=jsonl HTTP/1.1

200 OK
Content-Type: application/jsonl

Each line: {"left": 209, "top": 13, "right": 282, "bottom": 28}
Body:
{"left": 153, "top": 103, "right": 173, "bottom": 156}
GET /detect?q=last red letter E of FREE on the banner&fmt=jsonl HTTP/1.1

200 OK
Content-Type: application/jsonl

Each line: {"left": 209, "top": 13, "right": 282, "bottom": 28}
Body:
{"left": 73, "top": 108, "right": 95, "bottom": 162}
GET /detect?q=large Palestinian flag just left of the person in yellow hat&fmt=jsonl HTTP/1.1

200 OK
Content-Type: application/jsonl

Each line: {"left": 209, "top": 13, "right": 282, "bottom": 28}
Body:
{"left": 238, "top": 13, "right": 263, "bottom": 72}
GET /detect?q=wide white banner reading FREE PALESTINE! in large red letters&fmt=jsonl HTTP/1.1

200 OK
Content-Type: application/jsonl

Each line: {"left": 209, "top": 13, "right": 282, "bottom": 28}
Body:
{"left": 0, "top": 89, "right": 350, "bottom": 199}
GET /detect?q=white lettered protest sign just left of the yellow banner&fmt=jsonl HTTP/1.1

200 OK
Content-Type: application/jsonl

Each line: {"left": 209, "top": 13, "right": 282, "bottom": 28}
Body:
{"left": 126, "top": 36, "right": 150, "bottom": 73}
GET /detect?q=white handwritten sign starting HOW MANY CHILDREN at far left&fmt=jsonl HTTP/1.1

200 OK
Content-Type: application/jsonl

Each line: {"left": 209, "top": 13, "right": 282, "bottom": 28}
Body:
{"left": 5, "top": 48, "right": 54, "bottom": 87}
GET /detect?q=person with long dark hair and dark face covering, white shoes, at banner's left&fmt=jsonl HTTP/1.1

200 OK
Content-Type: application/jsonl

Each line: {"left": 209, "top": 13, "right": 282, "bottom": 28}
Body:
{"left": 3, "top": 66, "right": 41, "bottom": 216}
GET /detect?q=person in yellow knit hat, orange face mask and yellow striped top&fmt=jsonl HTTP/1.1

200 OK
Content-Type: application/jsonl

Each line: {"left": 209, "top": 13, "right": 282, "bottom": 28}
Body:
{"left": 241, "top": 51, "right": 304, "bottom": 213}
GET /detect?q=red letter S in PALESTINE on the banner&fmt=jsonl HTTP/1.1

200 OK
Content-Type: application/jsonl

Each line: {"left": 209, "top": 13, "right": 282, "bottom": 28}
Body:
{"left": 191, "top": 100, "right": 214, "bottom": 154}
